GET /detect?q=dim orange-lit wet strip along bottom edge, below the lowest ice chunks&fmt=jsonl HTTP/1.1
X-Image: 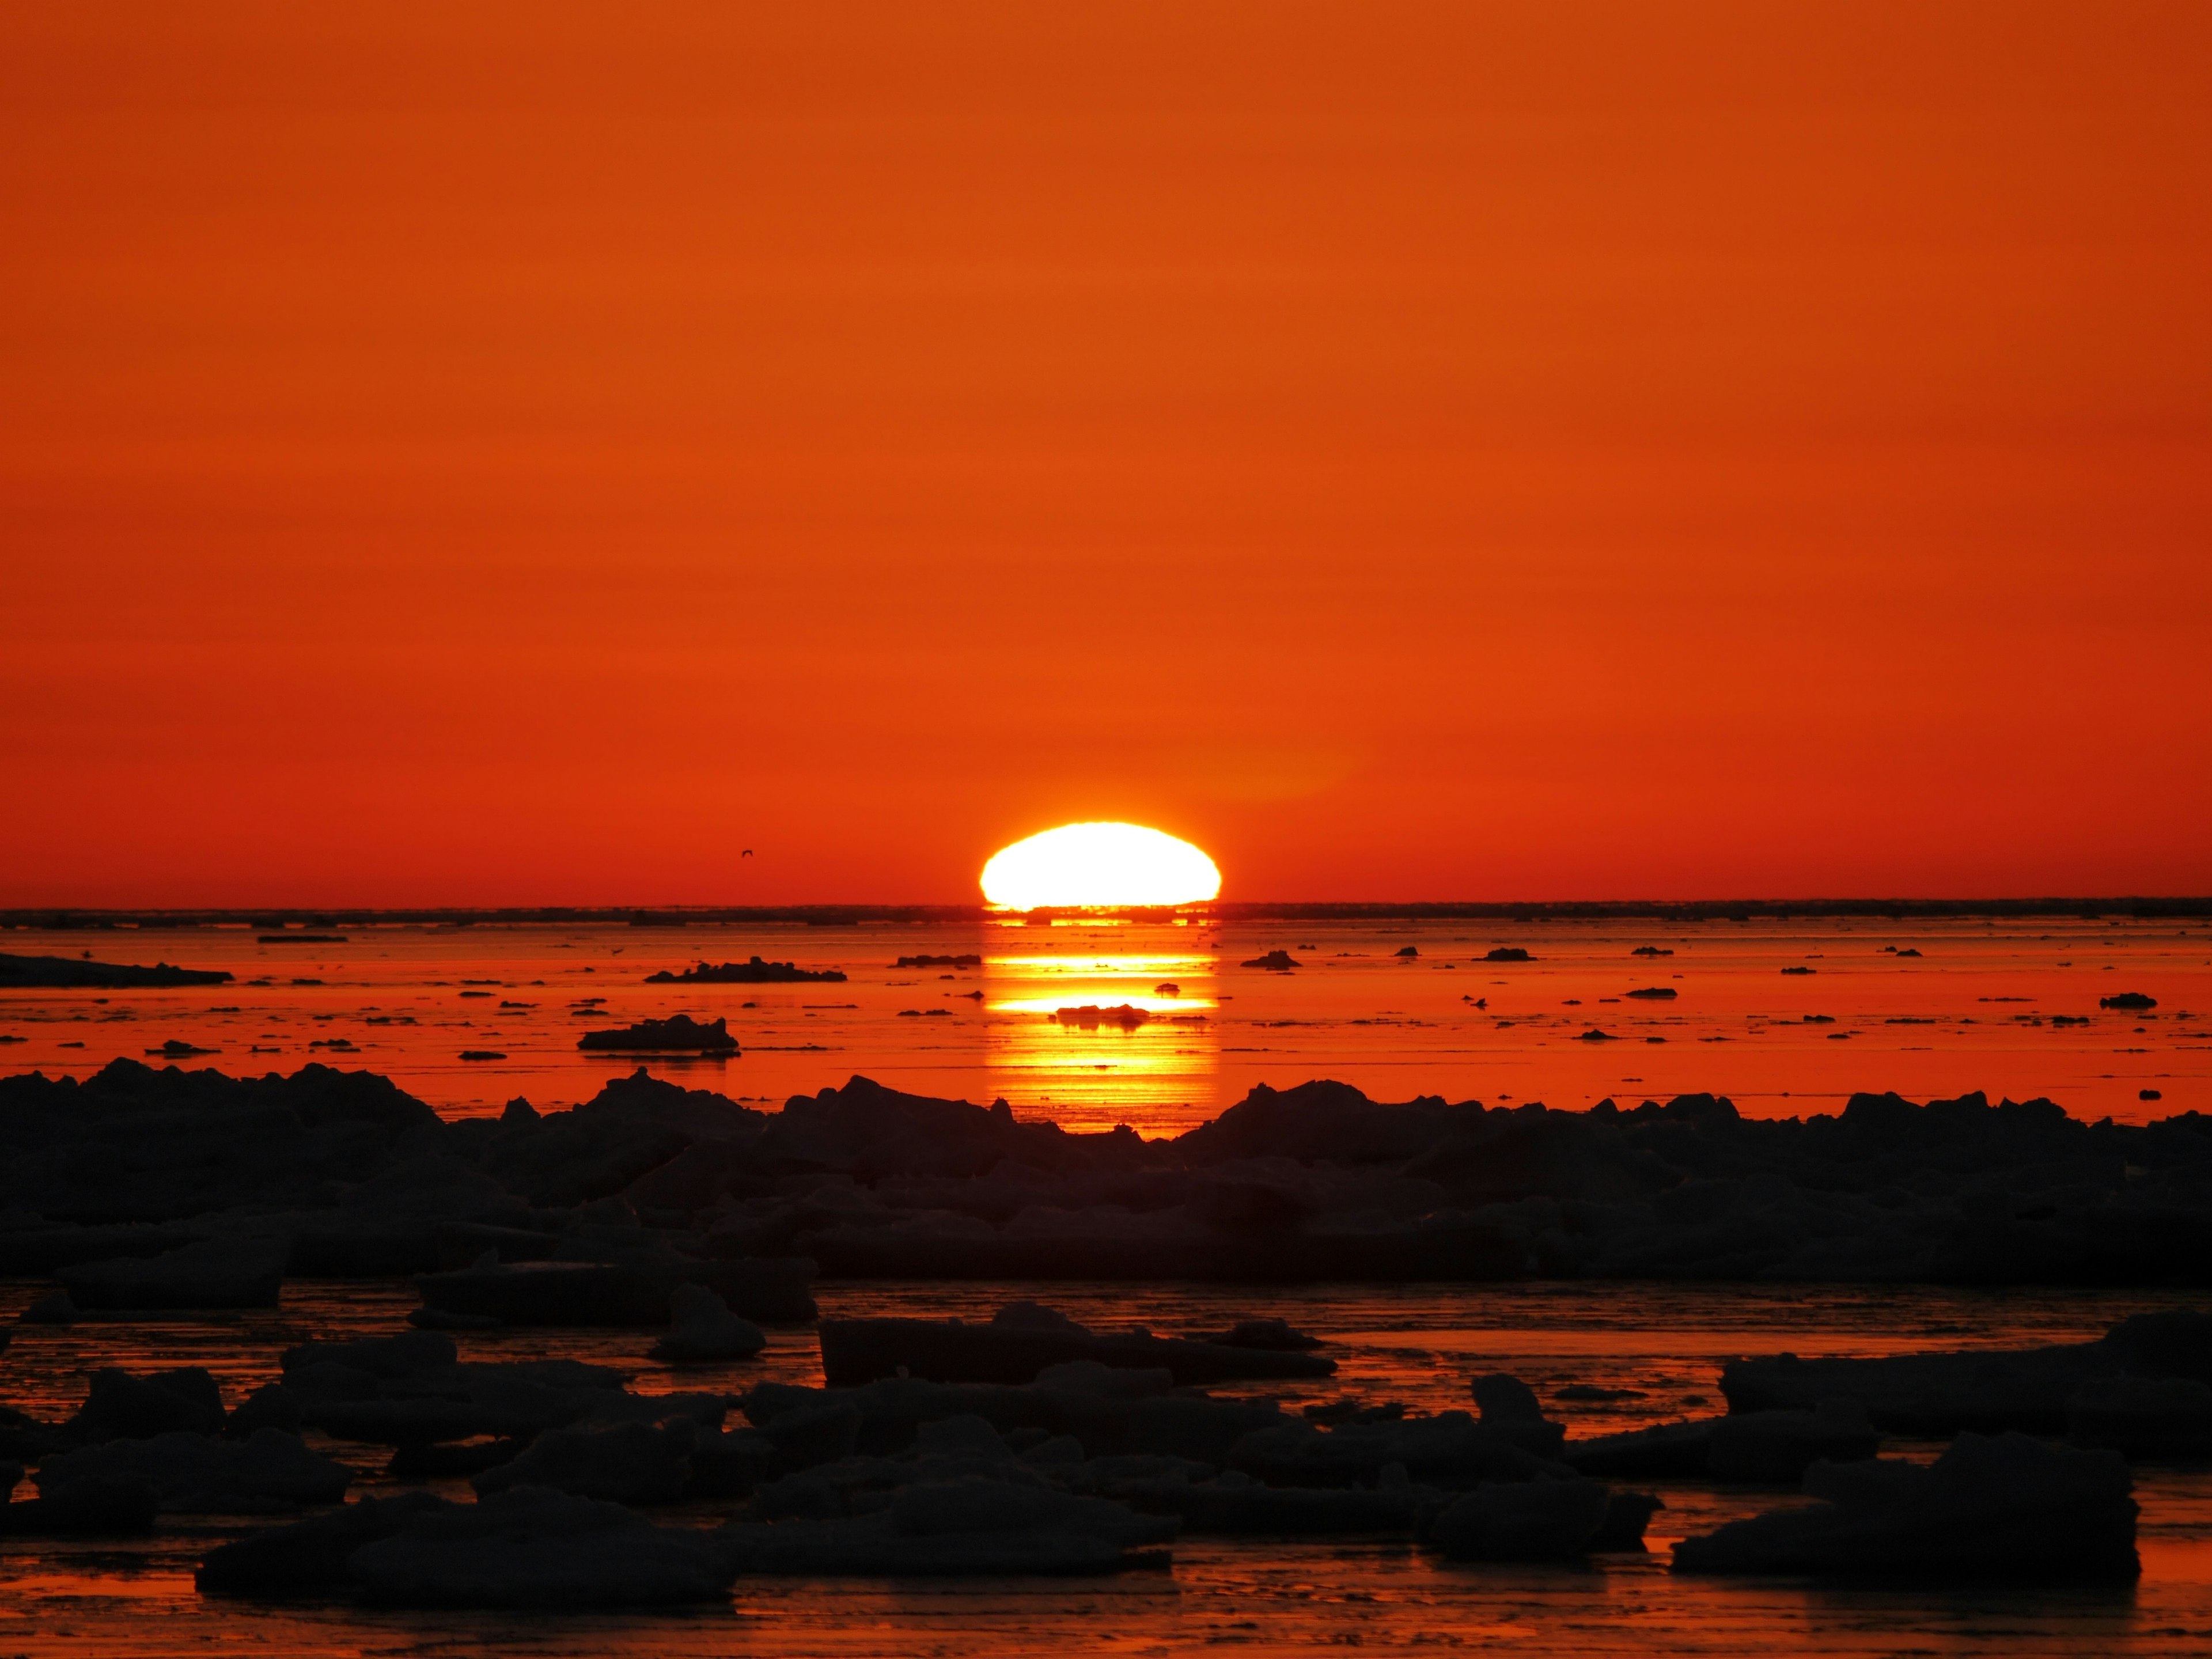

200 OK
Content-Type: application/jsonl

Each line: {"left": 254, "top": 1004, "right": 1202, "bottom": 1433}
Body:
{"left": 13, "top": 1540, "right": 2212, "bottom": 1659}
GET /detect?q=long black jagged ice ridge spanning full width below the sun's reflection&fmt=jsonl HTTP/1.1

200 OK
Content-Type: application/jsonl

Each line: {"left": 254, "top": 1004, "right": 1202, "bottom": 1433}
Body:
{"left": 0, "top": 1059, "right": 2212, "bottom": 1300}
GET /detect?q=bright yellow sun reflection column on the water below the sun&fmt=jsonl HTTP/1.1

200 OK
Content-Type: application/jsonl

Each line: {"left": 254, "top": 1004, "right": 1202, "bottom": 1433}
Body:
{"left": 984, "top": 947, "right": 1219, "bottom": 1137}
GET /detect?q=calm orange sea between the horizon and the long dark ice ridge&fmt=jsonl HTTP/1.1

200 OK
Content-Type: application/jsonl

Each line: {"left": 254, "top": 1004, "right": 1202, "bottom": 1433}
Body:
{"left": 0, "top": 918, "right": 2212, "bottom": 1135}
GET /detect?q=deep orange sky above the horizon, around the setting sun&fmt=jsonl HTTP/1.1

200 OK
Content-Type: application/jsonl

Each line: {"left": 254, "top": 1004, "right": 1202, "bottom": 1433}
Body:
{"left": 0, "top": 0, "right": 2212, "bottom": 905}
